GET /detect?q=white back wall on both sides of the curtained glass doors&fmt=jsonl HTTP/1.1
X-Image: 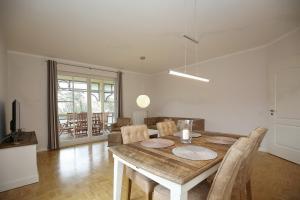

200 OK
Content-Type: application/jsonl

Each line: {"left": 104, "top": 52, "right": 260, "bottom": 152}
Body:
{"left": 6, "top": 52, "right": 152, "bottom": 150}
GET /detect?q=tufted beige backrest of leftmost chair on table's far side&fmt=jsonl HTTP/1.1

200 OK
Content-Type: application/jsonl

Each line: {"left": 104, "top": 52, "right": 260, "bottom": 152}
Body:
{"left": 121, "top": 124, "right": 149, "bottom": 144}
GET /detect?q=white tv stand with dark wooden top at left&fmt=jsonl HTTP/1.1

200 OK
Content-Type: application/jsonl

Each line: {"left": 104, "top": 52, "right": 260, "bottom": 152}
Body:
{"left": 0, "top": 132, "right": 39, "bottom": 192}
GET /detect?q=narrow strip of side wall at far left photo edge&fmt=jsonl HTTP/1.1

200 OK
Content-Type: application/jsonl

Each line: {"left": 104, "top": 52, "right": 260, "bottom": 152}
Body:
{"left": 0, "top": 24, "right": 6, "bottom": 136}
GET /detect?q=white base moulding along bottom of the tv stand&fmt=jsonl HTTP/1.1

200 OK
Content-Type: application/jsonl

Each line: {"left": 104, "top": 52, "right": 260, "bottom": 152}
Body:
{"left": 0, "top": 174, "right": 39, "bottom": 192}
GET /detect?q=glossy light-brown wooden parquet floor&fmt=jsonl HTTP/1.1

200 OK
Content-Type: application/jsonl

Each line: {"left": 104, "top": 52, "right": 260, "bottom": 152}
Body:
{"left": 0, "top": 142, "right": 300, "bottom": 200}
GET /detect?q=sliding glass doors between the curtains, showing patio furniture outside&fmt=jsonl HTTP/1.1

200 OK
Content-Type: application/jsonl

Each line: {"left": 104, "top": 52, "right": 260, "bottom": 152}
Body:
{"left": 57, "top": 72, "right": 116, "bottom": 143}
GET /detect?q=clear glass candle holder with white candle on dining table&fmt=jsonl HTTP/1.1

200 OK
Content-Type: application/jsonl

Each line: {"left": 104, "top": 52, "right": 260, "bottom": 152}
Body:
{"left": 178, "top": 120, "right": 193, "bottom": 144}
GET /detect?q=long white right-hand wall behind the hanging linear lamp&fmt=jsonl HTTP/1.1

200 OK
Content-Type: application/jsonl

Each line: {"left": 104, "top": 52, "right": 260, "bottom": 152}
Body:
{"left": 152, "top": 49, "right": 267, "bottom": 134}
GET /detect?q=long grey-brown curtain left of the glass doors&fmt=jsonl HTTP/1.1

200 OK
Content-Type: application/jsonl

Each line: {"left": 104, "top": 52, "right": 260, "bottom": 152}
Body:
{"left": 47, "top": 60, "right": 59, "bottom": 150}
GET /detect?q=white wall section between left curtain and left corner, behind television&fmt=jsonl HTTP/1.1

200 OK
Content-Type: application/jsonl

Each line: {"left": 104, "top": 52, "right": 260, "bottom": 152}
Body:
{"left": 6, "top": 53, "right": 47, "bottom": 150}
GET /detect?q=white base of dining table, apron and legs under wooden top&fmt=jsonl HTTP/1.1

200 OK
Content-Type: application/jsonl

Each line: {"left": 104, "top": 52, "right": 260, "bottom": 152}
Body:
{"left": 113, "top": 155, "right": 220, "bottom": 200}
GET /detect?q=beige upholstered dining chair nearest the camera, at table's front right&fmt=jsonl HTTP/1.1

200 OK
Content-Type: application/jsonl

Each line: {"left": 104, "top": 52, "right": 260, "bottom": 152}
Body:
{"left": 153, "top": 138, "right": 249, "bottom": 200}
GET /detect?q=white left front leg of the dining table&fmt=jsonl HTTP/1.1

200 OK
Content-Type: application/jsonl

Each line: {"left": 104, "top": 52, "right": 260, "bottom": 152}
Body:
{"left": 113, "top": 157, "right": 123, "bottom": 200}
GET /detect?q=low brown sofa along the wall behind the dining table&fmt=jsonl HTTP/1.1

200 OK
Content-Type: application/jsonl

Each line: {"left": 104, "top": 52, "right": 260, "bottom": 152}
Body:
{"left": 144, "top": 117, "right": 205, "bottom": 131}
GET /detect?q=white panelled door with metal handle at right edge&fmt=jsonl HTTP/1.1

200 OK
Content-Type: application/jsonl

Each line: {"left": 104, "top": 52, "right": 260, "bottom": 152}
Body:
{"left": 270, "top": 67, "right": 300, "bottom": 164}
